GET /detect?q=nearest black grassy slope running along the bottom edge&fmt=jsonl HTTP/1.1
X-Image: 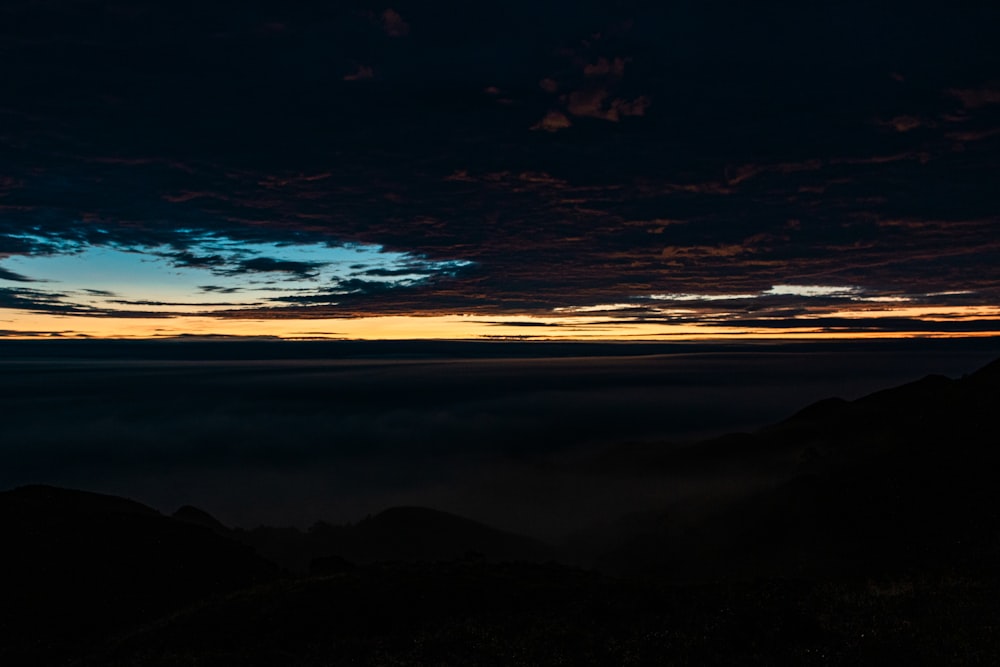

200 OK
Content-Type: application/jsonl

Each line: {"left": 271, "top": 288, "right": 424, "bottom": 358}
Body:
{"left": 95, "top": 562, "right": 1000, "bottom": 667}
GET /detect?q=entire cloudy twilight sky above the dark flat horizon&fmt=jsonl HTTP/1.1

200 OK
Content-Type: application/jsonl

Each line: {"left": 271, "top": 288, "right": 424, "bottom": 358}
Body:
{"left": 0, "top": 0, "right": 1000, "bottom": 340}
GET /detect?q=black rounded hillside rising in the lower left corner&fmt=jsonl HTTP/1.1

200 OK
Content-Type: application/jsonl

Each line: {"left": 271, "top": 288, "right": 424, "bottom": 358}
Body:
{"left": 0, "top": 486, "right": 275, "bottom": 665}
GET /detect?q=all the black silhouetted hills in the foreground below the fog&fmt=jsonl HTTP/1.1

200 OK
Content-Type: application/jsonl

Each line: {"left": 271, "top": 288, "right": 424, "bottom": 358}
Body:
{"left": 0, "top": 362, "right": 1000, "bottom": 665}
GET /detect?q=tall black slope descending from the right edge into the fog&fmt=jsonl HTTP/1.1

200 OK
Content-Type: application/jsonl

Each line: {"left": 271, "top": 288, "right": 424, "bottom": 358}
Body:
{"left": 602, "top": 363, "right": 1000, "bottom": 578}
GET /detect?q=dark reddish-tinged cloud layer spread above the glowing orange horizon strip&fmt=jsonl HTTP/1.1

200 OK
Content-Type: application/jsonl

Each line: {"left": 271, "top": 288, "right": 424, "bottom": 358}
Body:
{"left": 0, "top": 0, "right": 1000, "bottom": 334}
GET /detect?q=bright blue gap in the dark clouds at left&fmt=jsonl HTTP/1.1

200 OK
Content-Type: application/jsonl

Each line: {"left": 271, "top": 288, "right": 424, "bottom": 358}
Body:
{"left": 0, "top": 230, "right": 471, "bottom": 312}
